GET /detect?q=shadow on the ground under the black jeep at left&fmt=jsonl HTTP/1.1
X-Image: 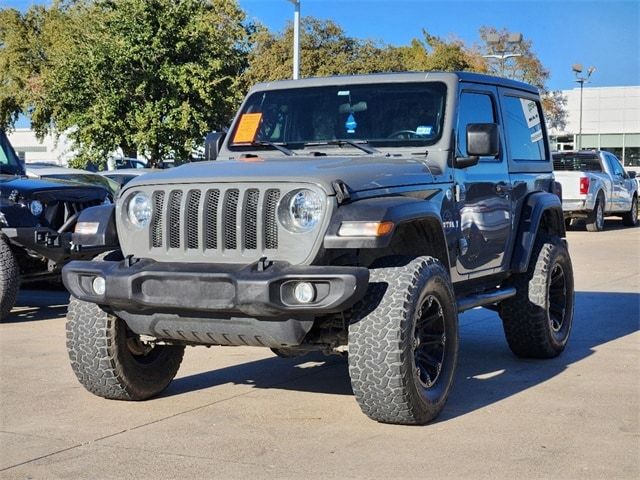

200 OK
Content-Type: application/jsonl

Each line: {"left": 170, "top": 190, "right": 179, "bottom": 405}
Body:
{"left": 2, "top": 288, "right": 69, "bottom": 323}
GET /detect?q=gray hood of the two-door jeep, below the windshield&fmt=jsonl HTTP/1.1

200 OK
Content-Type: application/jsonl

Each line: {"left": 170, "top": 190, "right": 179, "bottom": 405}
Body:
{"left": 125, "top": 155, "right": 441, "bottom": 195}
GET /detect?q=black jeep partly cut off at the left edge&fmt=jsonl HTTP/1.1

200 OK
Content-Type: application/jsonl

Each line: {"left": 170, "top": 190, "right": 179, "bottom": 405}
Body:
{"left": 0, "top": 130, "right": 110, "bottom": 322}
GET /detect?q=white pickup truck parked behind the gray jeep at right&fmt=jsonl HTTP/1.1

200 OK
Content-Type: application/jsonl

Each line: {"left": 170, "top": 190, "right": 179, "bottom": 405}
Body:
{"left": 553, "top": 150, "right": 638, "bottom": 232}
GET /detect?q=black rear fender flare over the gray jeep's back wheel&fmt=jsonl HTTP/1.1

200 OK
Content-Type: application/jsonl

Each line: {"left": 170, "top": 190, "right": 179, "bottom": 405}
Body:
{"left": 511, "top": 192, "right": 566, "bottom": 273}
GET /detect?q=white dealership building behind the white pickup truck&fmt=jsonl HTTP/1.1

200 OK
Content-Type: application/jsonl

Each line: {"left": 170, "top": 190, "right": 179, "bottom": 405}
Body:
{"left": 550, "top": 86, "right": 640, "bottom": 169}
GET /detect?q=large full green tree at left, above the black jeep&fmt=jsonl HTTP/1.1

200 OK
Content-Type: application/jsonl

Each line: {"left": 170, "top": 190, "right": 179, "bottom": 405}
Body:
{"left": 0, "top": 0, "right": 248, "bottom": 169}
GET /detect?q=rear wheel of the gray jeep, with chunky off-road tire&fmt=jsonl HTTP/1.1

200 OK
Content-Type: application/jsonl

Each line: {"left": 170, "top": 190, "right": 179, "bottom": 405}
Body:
{"left": 499, "top": 235, "right": 574, "bottom": 358}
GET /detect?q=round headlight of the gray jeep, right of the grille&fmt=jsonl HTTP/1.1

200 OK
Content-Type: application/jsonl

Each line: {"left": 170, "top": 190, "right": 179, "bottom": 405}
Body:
{"left": 278, "top": 188, "right": 323, "bottom": 232}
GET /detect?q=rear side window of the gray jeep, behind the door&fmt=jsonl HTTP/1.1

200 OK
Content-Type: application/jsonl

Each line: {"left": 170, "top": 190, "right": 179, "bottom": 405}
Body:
{"left": 504, "top": 96, "right": 546, "bottom": 161}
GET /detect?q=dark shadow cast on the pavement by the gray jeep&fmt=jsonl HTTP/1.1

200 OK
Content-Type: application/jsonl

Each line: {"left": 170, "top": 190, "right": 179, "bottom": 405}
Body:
{"left": 165, "top": 292, "right": 640, "bottom": 422}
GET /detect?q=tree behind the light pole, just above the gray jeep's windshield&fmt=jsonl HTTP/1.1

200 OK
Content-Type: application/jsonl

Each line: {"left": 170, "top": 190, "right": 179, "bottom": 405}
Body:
{"left": 243, "top": 17, "right": 402, "bottom": 86}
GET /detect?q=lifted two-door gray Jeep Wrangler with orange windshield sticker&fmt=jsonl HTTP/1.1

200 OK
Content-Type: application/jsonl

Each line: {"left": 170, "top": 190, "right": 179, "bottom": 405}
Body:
{"left": 63, "top": 73, "right": 574, "bottom": 424}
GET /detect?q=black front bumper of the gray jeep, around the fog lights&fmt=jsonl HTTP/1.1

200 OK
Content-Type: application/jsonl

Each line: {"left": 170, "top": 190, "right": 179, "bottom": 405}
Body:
{"left": 62, "top": 259, "right": 369, "bottom": 317}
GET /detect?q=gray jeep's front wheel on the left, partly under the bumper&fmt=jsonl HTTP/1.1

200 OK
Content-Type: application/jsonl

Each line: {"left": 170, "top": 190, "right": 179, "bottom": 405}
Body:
{"left": 67, "top": 297, "right": 184, "bottom": 400}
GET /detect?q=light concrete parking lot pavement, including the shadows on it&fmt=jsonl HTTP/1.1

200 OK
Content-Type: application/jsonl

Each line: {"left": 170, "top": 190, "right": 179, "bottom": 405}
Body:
{"left": 0, "top": 221, "right": 640, "bottom": 479}
